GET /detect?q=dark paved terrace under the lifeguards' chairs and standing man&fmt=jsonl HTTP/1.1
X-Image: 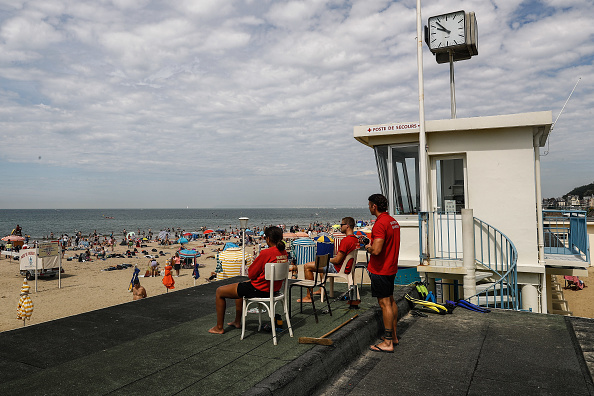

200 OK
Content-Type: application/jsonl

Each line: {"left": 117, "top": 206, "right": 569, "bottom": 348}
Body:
{"left": 0, "top": 278, "right": 594, "bottom": 395}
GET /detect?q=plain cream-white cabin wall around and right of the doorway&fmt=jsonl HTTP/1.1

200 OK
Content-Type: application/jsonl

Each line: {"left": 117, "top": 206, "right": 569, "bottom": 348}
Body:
{"left": 428, "top": 128, "right": 538, "bottom": 265}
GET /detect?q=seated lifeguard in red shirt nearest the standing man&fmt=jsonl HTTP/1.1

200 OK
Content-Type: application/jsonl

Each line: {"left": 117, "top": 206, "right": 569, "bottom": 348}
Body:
{"left": 297, "top": 217, "right": 359, "bottom": 302}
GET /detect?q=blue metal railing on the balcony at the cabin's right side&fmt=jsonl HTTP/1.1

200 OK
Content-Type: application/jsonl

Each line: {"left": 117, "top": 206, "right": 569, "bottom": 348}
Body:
{"left": 542, "top": 209, "right": 590, "bottom": 262}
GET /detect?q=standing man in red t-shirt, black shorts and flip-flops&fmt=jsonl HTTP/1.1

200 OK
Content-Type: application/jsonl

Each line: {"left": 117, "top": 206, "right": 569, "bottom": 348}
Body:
{"left": 365, "top": 194, "right": 400, "bottom": 353}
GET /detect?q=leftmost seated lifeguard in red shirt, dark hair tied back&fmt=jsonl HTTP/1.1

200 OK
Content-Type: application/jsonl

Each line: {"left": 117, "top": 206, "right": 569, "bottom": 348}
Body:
{"left": 208, "top": 227, "right": 287, "bottom": 334}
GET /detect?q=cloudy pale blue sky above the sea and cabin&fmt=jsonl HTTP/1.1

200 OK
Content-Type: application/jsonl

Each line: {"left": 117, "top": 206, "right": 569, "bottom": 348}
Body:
{"left": 0, "top": 0, "right": 594, "bottom": 209}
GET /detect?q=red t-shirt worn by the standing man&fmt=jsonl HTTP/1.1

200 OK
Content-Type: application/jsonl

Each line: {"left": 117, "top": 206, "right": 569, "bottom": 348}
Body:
{"left": 367, "top": 212, "right": 400, "bottom": 275}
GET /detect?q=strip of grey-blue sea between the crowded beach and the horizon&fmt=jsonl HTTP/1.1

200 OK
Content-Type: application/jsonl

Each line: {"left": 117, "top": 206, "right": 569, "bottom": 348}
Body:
{"left": 0, "top": 207, "right": 372, "bottom": 240}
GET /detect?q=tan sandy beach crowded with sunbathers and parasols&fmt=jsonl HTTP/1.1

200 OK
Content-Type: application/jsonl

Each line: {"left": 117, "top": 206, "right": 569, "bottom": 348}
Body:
{"left": 0, "top": 237, "right": 253, "bottom": 331}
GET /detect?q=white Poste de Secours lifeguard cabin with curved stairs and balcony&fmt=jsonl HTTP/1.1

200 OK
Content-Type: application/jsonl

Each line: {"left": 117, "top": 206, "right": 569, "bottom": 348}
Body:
{"left": 354, "top": 111, "right": 590, "bottom": 313}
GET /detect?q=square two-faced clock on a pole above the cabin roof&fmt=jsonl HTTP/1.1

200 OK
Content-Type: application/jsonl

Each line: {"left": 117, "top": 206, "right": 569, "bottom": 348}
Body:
{"left": 425, "top": 11, "right": 478, "bottom": 63}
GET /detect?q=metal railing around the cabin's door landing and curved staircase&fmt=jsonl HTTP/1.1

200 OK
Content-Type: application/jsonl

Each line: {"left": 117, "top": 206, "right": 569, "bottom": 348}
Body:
{"left": 419, "top": 212, "right": 520, "bottom": 310}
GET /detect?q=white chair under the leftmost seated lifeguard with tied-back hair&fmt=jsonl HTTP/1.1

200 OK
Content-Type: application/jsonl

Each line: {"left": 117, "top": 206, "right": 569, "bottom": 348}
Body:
{"left": 241, "top": 262, "right": 293, "bottom": 345}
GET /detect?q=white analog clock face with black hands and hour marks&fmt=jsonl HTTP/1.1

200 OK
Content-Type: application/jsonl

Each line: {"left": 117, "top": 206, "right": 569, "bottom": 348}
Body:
{"left": 429, "top": 11, "right": 466, "bottom": 50}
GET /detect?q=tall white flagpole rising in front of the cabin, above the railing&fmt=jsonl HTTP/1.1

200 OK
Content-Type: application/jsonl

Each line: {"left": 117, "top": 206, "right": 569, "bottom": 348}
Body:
{"left": 417, "top": 0, "right": 429, "bottom": 212}
